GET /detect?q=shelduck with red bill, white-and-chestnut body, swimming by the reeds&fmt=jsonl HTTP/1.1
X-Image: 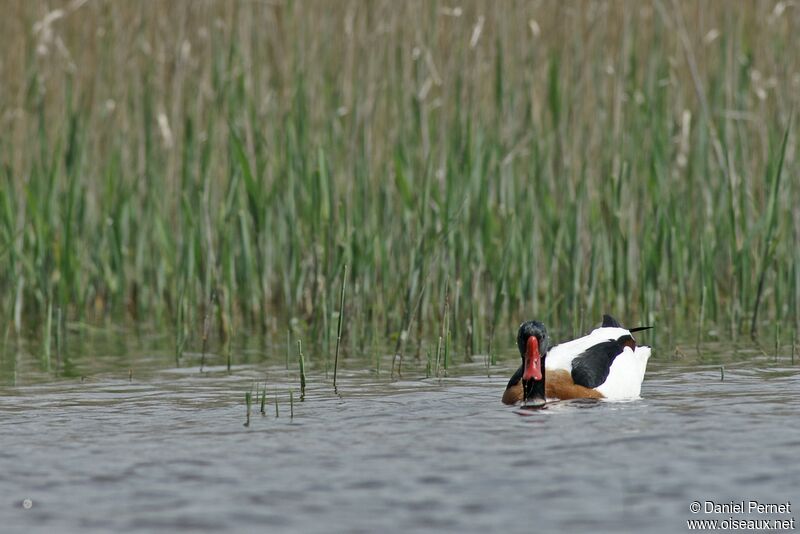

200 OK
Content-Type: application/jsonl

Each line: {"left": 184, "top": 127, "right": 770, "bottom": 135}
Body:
{"left": 503, "top": 314, "right": 652, "bottom": 407}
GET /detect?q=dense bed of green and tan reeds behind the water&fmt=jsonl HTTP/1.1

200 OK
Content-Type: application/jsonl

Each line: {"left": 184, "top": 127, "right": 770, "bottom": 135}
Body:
{"left": 0, "top": 0, "right": 800, "bottom": 364}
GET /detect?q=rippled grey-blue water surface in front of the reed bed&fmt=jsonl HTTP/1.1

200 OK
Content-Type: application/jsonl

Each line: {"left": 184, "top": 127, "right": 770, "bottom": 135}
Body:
{"left": 0, "top": 342, "right": 800, "bottom": 532}
